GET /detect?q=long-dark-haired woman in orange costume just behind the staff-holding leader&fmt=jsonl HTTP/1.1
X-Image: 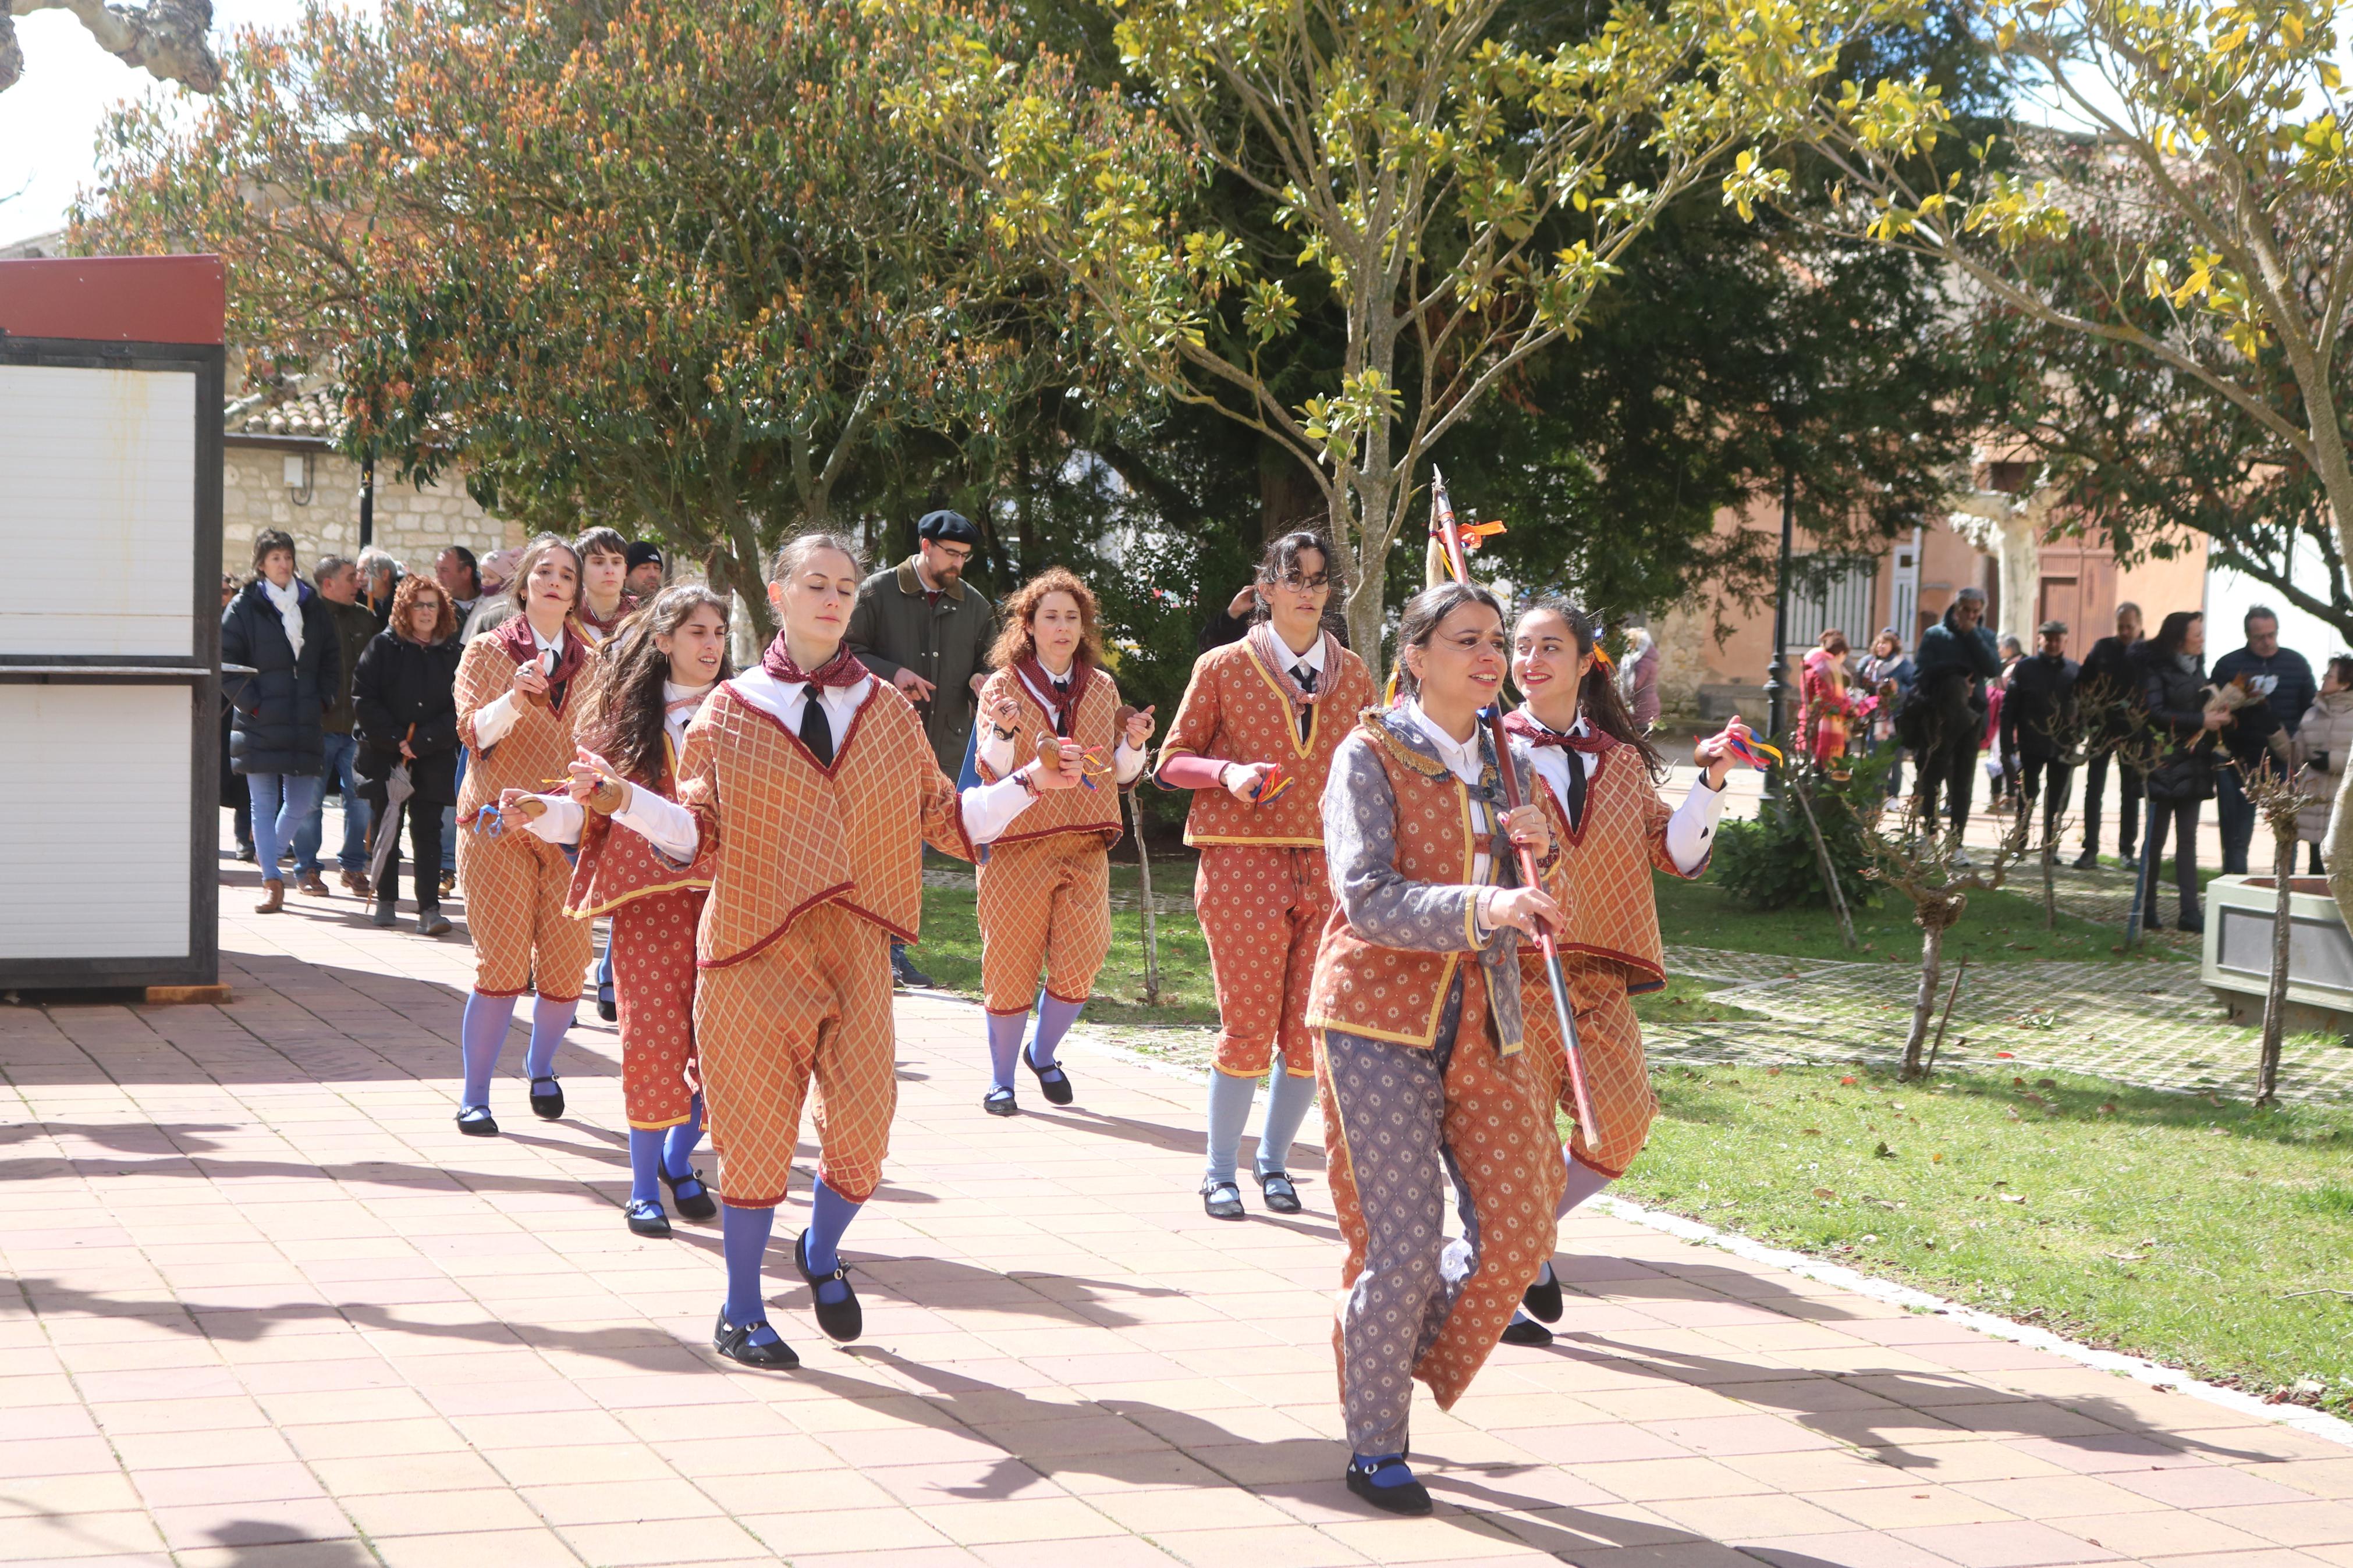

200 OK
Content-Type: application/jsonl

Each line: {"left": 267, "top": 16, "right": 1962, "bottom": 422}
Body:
{"left": 1503, "top": 599, "right": 1748, "bottom": 1345}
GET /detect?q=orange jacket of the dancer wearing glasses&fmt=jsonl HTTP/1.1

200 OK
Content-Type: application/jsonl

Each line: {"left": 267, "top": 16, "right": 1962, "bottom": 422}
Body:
{"left": 1160, "top": 637, "right": 1374, "bottom": 849}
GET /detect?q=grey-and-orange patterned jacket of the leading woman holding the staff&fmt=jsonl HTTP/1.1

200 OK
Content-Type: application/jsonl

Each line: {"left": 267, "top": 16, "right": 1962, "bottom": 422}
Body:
{"left": 1308, "top": 710, "right": 1565, "bottom": 1055}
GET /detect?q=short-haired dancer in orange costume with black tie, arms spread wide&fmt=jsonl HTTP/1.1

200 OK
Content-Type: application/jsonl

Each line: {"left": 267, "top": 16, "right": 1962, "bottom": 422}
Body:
{"left": 572, "top": 534, "right": 1077, "bottom": 1368}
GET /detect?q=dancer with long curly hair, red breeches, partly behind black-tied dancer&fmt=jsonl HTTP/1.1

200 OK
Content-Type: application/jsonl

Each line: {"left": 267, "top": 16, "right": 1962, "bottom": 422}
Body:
{"left": 499, "top": 585, "right": 734, "bottom": 1236}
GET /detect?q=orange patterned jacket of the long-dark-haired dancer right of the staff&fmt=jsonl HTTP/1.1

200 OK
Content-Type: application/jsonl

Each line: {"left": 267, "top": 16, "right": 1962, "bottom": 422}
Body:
{"left": 1520, "top": 741, "right": 1708, "bottom": 994}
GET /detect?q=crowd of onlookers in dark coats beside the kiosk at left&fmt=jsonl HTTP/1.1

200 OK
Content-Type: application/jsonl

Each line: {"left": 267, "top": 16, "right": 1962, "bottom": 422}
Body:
{"left": 221, "top": 529, "right": 663, "bottom": 936}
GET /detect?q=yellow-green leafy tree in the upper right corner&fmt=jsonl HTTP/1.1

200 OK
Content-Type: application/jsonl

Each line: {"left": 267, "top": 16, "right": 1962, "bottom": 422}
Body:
{"left": 1812, "top": 0, "right": 2353, "bottom": 912}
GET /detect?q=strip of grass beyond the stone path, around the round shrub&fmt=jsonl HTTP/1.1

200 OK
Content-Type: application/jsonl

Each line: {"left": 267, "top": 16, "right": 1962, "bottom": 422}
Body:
{"left": 1652, "top": 874, "right": 2179, "bottom": 964}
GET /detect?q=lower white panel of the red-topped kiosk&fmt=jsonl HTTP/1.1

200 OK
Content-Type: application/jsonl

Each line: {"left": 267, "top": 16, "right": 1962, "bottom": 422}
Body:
{"left": 0, "top": 684, "right": 193, "bottom": 959}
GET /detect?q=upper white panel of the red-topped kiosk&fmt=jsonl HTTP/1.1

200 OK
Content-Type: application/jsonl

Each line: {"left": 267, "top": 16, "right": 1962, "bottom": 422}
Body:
{"left": 0, "top": 364, "right": 210, "bottom": 658}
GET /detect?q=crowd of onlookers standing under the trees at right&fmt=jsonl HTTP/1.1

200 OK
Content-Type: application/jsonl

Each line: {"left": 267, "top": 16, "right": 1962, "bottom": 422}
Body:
{"left": 1798, "top": 588, "right": 2353, "bottom": 931}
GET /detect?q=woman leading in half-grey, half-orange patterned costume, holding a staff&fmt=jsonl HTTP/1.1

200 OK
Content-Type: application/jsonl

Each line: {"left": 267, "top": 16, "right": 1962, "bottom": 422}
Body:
{"left": 1308, "top": 583, "right": 1563, "bottom": 1514}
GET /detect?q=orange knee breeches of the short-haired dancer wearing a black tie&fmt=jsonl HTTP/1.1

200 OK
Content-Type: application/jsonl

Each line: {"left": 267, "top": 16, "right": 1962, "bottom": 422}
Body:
{"left": 694, "top": 903, "right": 899, "bottom": 1208}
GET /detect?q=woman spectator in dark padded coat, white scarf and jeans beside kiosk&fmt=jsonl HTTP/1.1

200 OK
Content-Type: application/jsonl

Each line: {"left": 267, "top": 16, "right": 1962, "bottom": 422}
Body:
{"left": 221, "top": 529, "right": 343, "bottom": 915}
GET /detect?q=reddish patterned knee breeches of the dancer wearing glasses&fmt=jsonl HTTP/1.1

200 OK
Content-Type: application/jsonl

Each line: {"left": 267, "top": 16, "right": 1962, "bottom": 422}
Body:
{"left": 1193, "top": 844, "right": 1332, "bottom": 1079}
